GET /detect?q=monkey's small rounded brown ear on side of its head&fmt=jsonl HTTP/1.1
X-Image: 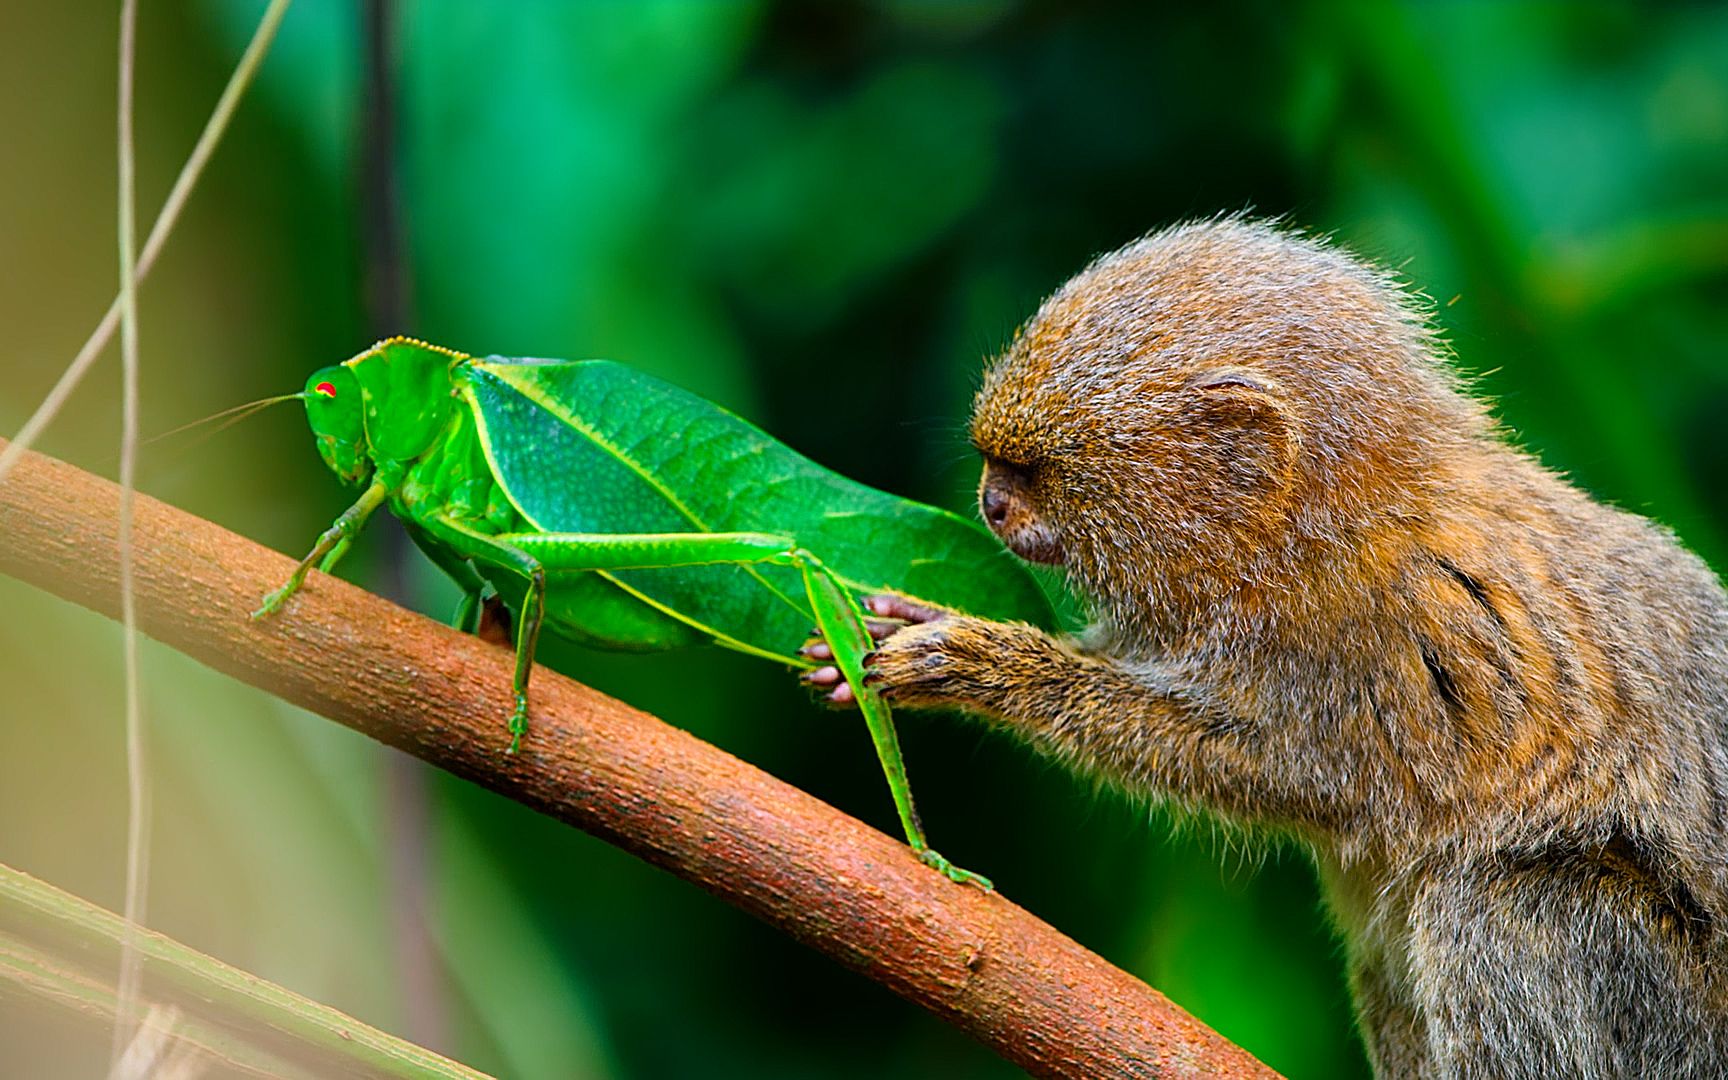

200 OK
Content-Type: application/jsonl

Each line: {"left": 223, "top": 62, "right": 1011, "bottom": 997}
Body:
{"left": 1189, "top": 368, "right": 1301, "bottom": 494}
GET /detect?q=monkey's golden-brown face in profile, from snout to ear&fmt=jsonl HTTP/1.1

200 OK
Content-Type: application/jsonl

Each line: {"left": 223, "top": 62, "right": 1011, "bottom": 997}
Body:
{"left": 971, "top": 321, "right": 1299, "bottom": 608}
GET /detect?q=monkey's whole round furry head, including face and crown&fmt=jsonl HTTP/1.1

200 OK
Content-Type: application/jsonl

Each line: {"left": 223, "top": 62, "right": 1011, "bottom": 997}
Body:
{"left": 971, "top": 218, "right": 1491, "bottom": 639}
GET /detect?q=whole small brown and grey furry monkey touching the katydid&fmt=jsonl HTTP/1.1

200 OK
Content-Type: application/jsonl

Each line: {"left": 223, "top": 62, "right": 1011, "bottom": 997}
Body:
{"left": 857, "top": 219, "right": 1728, "bottom": 1078}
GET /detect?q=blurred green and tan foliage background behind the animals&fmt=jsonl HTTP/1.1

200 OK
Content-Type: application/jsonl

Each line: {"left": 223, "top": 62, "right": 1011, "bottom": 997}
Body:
{"left": 0, "top": 0, "right": 1728, "bottom": 1078}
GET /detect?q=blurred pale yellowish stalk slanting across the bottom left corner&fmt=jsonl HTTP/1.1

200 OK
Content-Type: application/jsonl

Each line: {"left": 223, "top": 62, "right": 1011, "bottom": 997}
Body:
{"left": 0, "top": 866, "right": 486, "bottom": 1080}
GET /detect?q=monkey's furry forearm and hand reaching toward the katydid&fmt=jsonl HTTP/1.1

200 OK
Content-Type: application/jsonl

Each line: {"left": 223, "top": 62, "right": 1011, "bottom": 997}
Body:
{"left": 866, "top": 607, "right": 1341, "bottom": 821}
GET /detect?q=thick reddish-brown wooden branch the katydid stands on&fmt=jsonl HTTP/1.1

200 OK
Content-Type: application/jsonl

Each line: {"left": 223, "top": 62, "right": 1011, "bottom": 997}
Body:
{"left": 0, "top": 442, "right": 1274, "bottom": 1078}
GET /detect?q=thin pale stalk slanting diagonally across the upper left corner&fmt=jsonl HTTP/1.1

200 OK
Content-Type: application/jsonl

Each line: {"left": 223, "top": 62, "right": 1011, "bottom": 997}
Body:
{"left": 0, "top": 0, "right": 290, "bottom": 480}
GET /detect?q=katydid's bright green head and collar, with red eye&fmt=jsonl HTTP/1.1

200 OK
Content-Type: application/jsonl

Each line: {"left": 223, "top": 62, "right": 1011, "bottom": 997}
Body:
{"left": 304, "top": 337, "right": 467, "bottom": 484}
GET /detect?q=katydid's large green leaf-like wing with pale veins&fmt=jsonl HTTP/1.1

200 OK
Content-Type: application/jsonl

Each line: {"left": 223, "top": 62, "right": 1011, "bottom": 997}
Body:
{"left": 456, "top": 356, "right": 1051, "bottom": 658}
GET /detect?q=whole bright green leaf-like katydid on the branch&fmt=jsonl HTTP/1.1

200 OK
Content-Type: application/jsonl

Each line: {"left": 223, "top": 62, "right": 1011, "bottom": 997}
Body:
{"left": 257, "top": 337, "right": 1051, "bottom": 888}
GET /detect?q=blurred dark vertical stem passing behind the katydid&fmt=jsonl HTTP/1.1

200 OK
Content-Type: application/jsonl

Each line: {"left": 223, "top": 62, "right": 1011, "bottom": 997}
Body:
{"left": 359, "top": 0, "right": 448, "bottom": 1047}
